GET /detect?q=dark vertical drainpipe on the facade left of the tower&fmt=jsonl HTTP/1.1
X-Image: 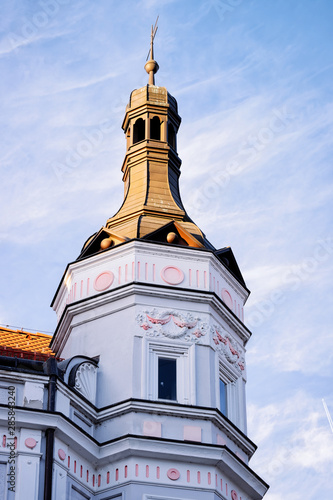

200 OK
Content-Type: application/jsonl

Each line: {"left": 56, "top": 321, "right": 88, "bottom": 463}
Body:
{"left": 44, "top": 358, "right": 57, "bottom": 500}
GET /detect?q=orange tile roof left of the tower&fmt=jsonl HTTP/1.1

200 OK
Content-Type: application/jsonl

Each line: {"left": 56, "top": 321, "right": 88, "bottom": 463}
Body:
{"left": 0, "top": 327, "right": 55, "bottom": 359}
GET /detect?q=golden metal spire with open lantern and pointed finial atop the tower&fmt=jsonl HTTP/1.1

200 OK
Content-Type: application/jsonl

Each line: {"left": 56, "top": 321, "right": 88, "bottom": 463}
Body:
{"left": 80, "top": 18, "right": 213, "bottom": 258}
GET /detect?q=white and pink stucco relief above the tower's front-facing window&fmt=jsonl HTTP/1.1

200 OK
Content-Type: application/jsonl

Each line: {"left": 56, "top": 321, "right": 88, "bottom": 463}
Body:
{"left": 136, "top": 309, "right": 209, "bottom": 342}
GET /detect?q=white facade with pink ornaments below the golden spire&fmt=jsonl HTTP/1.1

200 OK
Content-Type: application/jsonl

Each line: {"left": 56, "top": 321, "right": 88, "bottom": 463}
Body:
{"left": 0, "top": 237, "right": 266, "bottom": 500}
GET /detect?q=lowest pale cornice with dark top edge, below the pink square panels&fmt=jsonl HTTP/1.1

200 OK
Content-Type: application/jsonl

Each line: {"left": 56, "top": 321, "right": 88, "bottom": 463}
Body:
{"left": 0, "top": 405, "right": 268, "bottom": 499}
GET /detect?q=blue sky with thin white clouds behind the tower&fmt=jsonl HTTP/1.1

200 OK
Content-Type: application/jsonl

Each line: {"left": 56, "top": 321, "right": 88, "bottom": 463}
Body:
{"left": 0, "top": 0, "right": 333, "bottom": 500}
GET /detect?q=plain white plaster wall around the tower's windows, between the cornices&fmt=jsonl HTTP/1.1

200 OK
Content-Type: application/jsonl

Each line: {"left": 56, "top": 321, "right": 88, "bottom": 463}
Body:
{"left": 59, "top": 290, "right": 245, "bottom": 429}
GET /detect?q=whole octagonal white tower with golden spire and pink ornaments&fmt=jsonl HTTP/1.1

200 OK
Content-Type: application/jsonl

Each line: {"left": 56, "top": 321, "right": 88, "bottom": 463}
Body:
{"left": 0, "top": 28, "right": 267, "bottom": 500}
